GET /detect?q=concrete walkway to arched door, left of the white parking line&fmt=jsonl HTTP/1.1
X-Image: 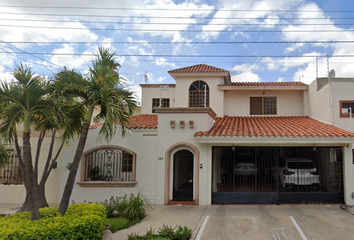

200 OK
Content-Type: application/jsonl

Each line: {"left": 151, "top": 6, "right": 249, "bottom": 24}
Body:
{"left": 111, "top": 205, "right": 207, "bottom": 240}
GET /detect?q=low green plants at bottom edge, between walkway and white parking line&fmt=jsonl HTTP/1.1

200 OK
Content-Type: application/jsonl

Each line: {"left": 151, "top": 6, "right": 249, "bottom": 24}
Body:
{"left": 128, "top": 224, "right": 192, "bottom": 240}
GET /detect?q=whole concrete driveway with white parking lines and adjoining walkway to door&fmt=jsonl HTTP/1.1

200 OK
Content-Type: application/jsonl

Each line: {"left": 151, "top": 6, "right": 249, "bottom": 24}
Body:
{"left": 112, "top": 205, "right": 354, "bottom": 240}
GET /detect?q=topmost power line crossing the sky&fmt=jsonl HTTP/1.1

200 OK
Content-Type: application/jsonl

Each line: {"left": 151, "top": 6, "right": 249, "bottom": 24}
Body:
{"left": 0, "top": 5, "right": 354, "bottom": 13}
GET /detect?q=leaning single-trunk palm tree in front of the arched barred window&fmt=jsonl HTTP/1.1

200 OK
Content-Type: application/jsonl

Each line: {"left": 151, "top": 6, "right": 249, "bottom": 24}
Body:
{"left": 53, "top": 47, "right": 137, "bottom": 215}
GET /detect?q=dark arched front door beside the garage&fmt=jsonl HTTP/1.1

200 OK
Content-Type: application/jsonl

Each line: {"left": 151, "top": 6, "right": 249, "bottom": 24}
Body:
{"left": 172, "top": 150, "right": 194, "bottom": 201}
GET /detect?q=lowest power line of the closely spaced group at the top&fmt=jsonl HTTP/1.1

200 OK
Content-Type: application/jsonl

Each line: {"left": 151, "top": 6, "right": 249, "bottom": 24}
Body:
{"left": 0, "top": 24, "right": 354, "bottom": 33}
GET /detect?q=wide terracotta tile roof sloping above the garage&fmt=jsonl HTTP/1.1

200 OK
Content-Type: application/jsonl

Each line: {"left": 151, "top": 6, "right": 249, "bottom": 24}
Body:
{"left": 194, "top": 117, "right": 354, "bottom": 138}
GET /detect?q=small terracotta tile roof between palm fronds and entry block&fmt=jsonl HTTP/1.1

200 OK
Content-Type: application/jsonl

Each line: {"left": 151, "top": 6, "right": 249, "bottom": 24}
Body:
{"left": 90, "top": 114, "right": 157, "bottom": 129}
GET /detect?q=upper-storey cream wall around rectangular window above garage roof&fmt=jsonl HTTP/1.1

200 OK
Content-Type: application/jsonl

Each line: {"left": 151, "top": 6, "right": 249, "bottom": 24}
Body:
{"left": 224, "top": 90, "right": 305, "bottom": 116}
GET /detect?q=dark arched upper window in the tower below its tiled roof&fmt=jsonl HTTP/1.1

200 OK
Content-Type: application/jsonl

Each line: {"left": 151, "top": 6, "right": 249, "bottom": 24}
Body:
{"left": 189, "top": 81, "right": 209, "bottom": 107}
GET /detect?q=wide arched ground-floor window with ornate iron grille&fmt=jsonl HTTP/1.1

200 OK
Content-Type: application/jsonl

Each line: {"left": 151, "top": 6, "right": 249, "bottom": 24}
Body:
{"left": 84, "top": 148, "right": 135, "bottom": 182}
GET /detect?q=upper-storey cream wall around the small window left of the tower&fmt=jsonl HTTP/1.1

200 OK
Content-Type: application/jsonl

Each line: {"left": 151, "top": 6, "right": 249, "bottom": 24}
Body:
{"left": 141, "top": 84, "right": 175, "bottom": 114}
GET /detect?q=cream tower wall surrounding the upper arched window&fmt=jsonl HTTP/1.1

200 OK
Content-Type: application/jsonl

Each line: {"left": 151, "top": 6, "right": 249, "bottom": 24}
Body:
{"left": 175, "top": 76, "right": 224, "bottom": 116}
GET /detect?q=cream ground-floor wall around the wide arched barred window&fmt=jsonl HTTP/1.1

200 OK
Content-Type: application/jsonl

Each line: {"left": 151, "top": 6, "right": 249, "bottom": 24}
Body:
{"left": 60, "top": 129, "right": 163, "bottom": 204}
